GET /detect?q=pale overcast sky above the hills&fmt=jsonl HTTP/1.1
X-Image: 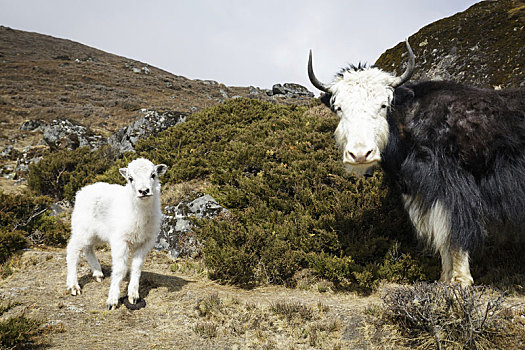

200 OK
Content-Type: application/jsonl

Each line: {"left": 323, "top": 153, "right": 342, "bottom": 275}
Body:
{"left": 0, "top": 0, "right": 478, "bottom": 91}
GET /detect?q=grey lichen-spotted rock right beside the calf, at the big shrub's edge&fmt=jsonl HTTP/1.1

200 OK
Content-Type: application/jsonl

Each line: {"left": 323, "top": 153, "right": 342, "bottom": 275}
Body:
{"left": 155, "top": 195, "right": 228, "bottom": 258}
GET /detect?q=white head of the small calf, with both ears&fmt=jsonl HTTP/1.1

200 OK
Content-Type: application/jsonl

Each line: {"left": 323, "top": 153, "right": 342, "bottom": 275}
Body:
{"left": 119, "top": 158, "right": 167, "bottom": 200}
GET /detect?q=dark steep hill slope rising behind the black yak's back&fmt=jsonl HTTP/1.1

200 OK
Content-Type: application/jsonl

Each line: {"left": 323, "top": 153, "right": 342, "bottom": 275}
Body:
{"left": 375, "top": 0, "right": 525, "bottom": 88}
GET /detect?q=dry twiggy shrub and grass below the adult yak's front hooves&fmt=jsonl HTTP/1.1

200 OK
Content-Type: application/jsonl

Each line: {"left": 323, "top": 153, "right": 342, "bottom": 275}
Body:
{"left": 365, "top": 283, "right": 525, "bottom": 350}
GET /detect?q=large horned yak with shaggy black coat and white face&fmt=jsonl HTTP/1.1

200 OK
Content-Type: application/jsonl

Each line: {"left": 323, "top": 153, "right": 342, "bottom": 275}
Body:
{"left": 308, "top": 41, "right": 525, "bottom": 285}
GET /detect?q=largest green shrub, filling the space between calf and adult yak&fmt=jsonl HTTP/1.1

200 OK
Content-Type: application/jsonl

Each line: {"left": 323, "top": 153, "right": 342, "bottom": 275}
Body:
{"left": 131, "top": 99, "right": 426, "bottom": 288}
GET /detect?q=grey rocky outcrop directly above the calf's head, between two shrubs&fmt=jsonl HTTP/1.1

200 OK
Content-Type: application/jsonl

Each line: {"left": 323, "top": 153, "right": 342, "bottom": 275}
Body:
{"left": 108, "top": 110, "right": 187, "bottom": 156}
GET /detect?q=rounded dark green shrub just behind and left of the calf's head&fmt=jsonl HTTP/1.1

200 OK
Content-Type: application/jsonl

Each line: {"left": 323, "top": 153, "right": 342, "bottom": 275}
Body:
{"left": 28, "top": 147, "right": 114, "bottom": 200}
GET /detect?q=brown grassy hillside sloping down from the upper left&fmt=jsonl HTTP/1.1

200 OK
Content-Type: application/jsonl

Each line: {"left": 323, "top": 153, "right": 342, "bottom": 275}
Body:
{"left": 0, "top": 26, "right": 311, "bottom": 191}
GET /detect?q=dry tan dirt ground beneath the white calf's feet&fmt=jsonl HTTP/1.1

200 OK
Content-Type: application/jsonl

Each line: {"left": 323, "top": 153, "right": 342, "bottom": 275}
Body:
{"left": 0, "top": 249, "right": 380, "bottom": 349}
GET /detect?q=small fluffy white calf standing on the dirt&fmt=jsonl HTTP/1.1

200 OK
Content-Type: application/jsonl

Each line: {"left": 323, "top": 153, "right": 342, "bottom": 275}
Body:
{"left": 66, "top": 158, "right": 167, "bottom": 309}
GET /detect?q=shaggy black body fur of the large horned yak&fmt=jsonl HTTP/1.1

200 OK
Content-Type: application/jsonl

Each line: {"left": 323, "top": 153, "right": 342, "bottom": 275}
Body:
{"left": 381, "top": 81, "right": 525, "bottom": 252}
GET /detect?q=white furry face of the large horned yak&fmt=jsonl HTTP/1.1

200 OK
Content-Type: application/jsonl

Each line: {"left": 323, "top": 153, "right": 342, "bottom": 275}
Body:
{"left": 328, "top": 68, "right": 395, "bottom": 176}
